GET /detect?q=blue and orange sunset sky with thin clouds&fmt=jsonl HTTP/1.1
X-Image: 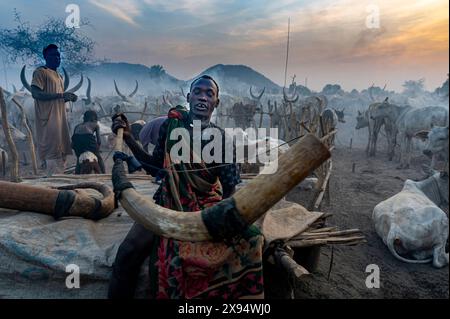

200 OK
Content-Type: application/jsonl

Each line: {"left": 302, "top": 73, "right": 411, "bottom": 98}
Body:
{"left": 0, "top": 0, "right": 449, "bottom": 91}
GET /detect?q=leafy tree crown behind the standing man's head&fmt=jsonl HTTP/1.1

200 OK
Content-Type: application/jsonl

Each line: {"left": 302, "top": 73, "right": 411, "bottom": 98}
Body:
{"left": 0, "top": 10, "right": 95, "bottom": 72}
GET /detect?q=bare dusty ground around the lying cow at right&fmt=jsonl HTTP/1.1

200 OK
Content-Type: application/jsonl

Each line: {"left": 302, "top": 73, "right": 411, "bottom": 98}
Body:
{"left": 288, "top": 145, "right": 449, "bottom": 298}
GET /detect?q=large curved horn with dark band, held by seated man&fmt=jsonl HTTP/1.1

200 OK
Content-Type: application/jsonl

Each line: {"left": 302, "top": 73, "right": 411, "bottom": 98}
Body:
{"left": 120, "top": 134, "right": 331, "bottom": 241}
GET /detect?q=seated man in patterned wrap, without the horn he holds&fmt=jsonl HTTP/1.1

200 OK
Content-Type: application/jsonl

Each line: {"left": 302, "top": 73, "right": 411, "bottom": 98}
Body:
{"left": 108, "top": 75, "right": 264, "bottom": 299}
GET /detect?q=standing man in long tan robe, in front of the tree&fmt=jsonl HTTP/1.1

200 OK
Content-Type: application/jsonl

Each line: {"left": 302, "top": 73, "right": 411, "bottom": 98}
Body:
{"left": 31, "top": 44, "right": 77, "bottom": 175}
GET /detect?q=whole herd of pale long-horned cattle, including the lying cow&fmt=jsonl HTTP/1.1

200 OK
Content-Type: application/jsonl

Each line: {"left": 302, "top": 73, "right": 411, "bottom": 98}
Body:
{"left": 0, "top": 67, "right": 449, "bottom": 267}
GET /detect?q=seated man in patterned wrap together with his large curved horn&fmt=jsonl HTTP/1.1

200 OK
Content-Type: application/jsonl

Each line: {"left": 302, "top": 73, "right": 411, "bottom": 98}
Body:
{"left": 108, "top": 76, "right": 330, "bottom": 299}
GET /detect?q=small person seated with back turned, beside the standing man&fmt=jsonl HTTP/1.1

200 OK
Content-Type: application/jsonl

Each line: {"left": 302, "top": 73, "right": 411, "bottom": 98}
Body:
{"left": 72, "top": 110, "right": 105, "bottom": 174}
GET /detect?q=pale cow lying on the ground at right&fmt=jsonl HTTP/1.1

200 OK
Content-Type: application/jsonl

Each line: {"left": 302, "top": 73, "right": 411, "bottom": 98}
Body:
{"left": 372, "top": 170, "right": 449, "bottom": 268}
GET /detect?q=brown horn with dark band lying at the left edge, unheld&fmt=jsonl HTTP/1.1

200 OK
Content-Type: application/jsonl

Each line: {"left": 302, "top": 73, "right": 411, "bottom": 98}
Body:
{"left": 0, "top": 181, "right": 114, "bottom": 220}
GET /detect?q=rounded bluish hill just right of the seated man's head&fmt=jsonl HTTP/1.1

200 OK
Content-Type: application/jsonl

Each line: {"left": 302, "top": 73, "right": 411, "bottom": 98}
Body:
{"left": 189, "top": 64, "right": 281, "bottom": 94}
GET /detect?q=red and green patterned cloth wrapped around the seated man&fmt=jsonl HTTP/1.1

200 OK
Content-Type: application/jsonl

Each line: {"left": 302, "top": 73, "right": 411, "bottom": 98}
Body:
{"left": 150, "top": 106, "right": 264, "bottom": 299}
